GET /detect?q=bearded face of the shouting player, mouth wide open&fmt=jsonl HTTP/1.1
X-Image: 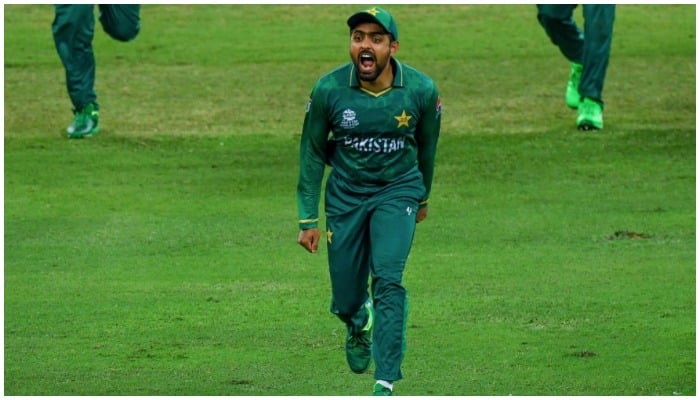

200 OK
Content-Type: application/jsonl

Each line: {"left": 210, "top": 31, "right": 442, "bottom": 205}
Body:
{"left": 350, "top": 23, "right": 399, "bottom": 82}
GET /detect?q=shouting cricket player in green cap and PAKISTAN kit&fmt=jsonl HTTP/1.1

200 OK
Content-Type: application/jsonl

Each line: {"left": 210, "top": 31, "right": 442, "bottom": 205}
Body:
{"left": 297, "top": 7, "right": 442, "bottom": 395}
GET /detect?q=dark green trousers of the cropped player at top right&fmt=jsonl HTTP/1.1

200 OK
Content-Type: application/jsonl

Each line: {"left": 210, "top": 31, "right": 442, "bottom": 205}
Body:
{"left": 537, "top": 4, "right": 615, "bottom": 104}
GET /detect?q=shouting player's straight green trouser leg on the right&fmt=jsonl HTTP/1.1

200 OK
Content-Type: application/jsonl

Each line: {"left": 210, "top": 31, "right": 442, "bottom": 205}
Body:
{"left": 370, "top": 198, "right": 418, "bottom": 382}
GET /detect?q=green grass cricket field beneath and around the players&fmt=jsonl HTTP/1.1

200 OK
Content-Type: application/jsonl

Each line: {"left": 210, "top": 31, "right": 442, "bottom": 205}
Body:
{"left": 4, "top": 5, "right": 696, "bottom": 396}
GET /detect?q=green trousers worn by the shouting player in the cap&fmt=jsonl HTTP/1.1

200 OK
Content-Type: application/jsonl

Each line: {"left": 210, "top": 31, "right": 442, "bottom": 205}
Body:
{"left": 325, "top": 171, "right": 425, "bottom": 382}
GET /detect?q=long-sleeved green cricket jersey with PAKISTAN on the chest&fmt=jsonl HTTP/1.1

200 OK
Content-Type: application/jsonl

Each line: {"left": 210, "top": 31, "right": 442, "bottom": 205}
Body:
{"left": 297, "top": 58, "right": 442, "bottom": 229}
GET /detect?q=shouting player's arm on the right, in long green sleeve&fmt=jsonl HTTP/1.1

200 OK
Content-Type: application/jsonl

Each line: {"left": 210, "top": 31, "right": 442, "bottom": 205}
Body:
{"left": 415, "top": 82, "right": 442, "bottom": 222}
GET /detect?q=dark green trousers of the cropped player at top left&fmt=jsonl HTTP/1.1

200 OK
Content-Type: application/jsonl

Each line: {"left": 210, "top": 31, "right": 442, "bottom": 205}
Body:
{"left": 51, "top": 4, "right": 141, "bottom": 110}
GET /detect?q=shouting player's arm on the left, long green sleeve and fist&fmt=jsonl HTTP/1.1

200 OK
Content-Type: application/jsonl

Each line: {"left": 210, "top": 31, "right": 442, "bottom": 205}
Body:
{"left": 297, "top": 84, "right": 330, "bottom": 248}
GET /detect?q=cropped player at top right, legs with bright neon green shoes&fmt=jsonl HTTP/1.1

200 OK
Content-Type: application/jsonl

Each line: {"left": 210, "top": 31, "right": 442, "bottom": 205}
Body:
{"left": 537, "top": 4, "right": 615, "bottom": 130}
